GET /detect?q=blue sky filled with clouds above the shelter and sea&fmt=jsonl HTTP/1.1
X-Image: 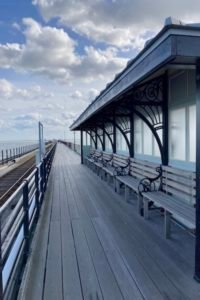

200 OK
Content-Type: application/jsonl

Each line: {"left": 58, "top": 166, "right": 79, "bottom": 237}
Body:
{"left": 0, "top": 0, "right": 200, "bottom": 141}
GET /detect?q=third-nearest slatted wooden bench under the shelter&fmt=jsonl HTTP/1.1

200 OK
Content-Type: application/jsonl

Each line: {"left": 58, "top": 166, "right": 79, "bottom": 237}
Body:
{"left": 102, "top": 154, "right": 129, "bottom": 183}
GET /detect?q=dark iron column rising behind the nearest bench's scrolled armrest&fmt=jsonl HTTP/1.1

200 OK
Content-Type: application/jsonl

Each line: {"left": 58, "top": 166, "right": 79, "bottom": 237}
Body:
{"left": 161, "top": 71, "right": 169, "bottom": 166}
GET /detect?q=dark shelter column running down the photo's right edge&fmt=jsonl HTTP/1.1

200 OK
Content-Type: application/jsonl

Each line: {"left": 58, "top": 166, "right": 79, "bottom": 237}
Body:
{"left": 194, "top": 60, "right": 200, "bottom": 282}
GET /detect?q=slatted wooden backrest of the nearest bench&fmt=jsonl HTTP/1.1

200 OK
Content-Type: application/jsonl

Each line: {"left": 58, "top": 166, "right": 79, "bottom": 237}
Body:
{"left": 162, "top": 166, "right": 196, "bottom": 204}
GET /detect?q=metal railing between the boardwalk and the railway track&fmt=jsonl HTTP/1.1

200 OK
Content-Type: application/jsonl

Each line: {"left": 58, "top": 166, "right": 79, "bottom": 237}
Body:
{"left": 0, "top": 145, "right": 56, "bottom": 300}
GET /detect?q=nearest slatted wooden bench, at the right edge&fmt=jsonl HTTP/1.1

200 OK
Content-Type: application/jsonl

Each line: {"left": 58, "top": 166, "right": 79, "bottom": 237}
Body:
{"left": 143, "top": 166, "right": 196, "bottom": 238}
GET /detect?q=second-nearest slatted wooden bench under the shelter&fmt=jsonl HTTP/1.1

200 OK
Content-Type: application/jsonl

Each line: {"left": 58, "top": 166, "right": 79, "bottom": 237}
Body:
{"left": 116, "top": 158, "right": 161, "bottom": 213}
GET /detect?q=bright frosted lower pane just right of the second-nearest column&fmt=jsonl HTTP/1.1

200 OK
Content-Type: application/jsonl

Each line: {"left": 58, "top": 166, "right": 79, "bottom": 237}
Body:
{"left": 169, "top": 108, "right": 186, "bottom": 160}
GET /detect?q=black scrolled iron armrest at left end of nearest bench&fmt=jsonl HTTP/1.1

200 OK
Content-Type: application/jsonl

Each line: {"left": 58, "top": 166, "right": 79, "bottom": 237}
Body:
{"left": 138, "top": 166, "right": 162, "bottom": 196}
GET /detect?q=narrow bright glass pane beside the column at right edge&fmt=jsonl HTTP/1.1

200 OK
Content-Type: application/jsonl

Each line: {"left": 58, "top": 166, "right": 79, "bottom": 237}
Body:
{"left": 189, "top": 105, "right": 196, "bottom": 162}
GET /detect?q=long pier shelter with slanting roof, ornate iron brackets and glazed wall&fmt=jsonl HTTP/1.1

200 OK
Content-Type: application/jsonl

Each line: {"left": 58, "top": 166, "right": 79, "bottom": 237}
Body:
{"left": 71, "top": 18, "right": 200, "bottom": 281}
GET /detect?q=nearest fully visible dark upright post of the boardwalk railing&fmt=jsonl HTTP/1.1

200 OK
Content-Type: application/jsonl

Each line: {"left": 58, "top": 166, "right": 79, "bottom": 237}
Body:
{"left": 23, "top": 180, "right": 29, "bottom": 263}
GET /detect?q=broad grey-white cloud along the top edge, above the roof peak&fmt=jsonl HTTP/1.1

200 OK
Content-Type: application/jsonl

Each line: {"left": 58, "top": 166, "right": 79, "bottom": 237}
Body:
{"left": 33, "top": 0, "right": 200, "bottom": 48}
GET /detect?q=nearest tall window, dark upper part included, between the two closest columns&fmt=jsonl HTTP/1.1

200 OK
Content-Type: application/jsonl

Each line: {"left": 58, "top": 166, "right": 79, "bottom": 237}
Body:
{"left": 169, "top": 70, "right": 196, "bottom": 163}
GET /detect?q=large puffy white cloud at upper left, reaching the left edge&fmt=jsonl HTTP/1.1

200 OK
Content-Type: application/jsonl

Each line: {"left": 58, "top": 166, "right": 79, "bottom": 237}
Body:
{"left": 0, "top": 18, "right": 127, "bottom": 83}
